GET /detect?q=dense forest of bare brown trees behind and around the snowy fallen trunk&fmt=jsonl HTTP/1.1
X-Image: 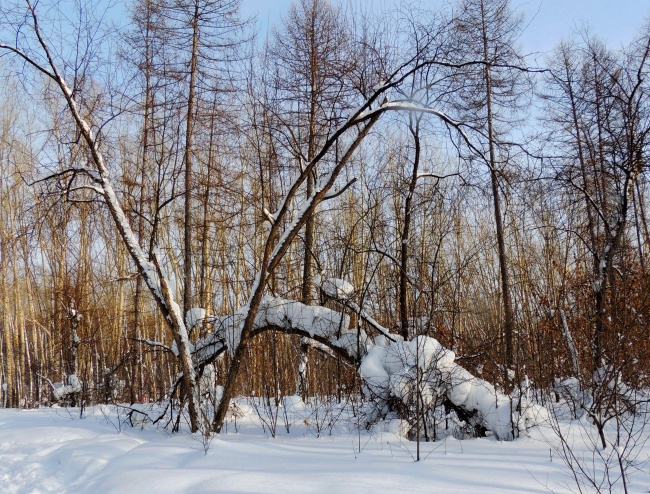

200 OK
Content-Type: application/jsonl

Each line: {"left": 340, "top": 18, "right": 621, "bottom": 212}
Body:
{"left": 0, "top": 0, "right": 650, "bottom": 440}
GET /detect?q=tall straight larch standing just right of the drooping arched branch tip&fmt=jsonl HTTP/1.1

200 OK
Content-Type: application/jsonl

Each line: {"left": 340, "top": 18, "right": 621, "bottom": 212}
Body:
{"left": 448, "top": 0, "right": 527, "bottom": 380}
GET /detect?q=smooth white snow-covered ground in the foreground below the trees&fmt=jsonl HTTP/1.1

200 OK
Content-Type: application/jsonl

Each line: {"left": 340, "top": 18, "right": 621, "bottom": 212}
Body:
{"left": 0, "top": 405, "right": 650, "bottom": 494}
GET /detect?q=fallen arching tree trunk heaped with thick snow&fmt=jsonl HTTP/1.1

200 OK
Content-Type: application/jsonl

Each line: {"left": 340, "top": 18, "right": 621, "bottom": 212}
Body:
{"left": 178, "top": 280, "right": 547, "bottom": 440}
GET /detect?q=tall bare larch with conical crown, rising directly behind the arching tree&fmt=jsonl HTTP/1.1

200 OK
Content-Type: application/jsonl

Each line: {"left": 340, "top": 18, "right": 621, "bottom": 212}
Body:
{"left": 271, "top": 0, "right": 354, "bottom": 304}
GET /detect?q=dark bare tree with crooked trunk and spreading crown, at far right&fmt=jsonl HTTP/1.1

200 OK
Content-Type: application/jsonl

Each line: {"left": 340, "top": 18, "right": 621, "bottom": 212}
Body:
{"left": 547, "top": 35, "right": 650, "bottom": 375}
